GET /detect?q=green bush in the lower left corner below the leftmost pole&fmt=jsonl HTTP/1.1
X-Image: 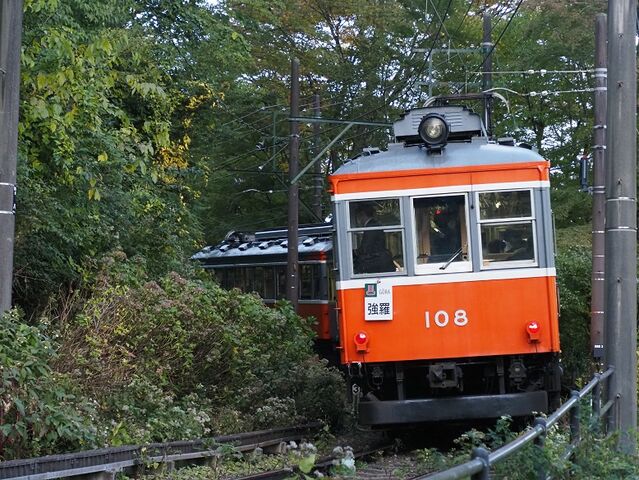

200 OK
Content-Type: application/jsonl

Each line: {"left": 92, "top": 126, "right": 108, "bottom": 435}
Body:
{"left": 0, "top": 311, "right": 98, "bottom": 459}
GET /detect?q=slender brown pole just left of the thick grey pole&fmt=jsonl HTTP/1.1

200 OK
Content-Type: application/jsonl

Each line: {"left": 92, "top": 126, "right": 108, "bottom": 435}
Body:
{"left": 590, "top": 13, "right": 608, "bottom": 359}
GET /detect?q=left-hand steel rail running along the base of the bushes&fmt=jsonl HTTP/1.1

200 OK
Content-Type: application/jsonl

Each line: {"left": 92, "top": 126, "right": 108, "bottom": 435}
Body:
{"left": 0, "top": 423, "right": 321, "bottom": 480}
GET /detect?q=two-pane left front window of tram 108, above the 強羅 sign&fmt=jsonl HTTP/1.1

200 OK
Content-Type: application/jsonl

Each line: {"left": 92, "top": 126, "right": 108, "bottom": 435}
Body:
{"left": 348, "top": 198, "right": 404, "bottom": 275}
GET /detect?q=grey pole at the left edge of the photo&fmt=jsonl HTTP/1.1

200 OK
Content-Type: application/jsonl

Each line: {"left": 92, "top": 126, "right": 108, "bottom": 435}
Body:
{"left": 0, "top": 0, "right": 22, "bottom": 313}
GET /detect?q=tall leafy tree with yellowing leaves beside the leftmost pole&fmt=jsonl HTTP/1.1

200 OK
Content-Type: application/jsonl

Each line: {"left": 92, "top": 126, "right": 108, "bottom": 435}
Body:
{"left": 16, "top": 0, "right": 218, "bottom": 314}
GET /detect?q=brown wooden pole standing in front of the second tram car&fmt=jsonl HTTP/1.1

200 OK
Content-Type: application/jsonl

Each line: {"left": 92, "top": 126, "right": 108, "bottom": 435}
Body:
{"left": 286, "top": 58, "right": 300, "bottom": 312}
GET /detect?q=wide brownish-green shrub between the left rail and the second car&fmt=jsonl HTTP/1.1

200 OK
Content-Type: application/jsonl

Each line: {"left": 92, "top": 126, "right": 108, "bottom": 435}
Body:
{"left": 49, "top": 253, "right": 345, "bottom": 443}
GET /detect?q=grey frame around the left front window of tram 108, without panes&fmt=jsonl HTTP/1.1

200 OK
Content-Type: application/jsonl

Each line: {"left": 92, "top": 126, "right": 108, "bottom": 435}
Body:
{"left": 344, "top": 196, "right": 408, "bottom": 278}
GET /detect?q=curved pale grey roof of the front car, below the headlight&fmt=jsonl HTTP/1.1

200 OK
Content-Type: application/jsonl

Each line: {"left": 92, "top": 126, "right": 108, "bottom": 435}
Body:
{"left": 333, "top": 137, "right": 544, "bottom": 175}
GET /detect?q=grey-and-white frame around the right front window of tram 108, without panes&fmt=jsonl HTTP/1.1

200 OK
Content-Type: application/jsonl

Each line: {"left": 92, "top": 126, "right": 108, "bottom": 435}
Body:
{"left": 473, "top": 188, "right": 539, "bottom": 270}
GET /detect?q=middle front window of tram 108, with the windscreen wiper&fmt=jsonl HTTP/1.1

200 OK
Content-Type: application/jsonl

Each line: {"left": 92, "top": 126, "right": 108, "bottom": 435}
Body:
{"left": 413, "top": 195, "right": 471, "bottom": 273}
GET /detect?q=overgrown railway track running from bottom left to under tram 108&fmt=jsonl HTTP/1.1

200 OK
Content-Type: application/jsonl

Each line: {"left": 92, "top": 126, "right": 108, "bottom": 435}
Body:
{"left": 0, "top": 418, "right": 552, "bottom": 480}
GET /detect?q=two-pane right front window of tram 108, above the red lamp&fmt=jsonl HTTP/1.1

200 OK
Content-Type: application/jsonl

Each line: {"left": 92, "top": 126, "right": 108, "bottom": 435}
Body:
{"left": 477, "top": 190, "right": 536, "bottom": 267}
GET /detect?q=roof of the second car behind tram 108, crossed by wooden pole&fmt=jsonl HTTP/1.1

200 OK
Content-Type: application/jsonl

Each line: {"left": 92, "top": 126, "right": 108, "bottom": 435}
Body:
{"left": 191, "top": 223, "right": 333, "bottom": 265}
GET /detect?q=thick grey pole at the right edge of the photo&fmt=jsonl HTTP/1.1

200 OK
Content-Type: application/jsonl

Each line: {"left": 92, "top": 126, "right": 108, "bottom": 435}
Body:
{"left": 604, "top": 0, "right": 637, "bottom": 454}
